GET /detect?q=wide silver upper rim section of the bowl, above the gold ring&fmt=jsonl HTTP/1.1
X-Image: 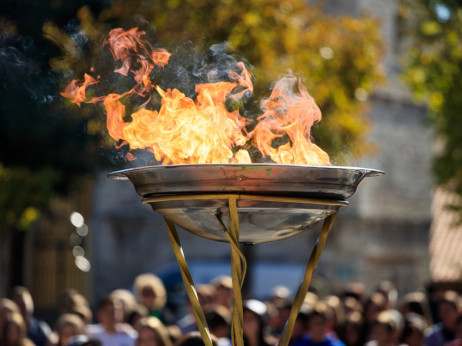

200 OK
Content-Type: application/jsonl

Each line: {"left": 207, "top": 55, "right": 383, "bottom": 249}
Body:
{"left": 109, "top": 164, "right": 383, "bottom": 200}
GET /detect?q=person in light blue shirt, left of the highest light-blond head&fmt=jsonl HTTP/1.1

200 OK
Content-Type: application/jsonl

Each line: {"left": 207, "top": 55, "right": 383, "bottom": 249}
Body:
{"left": 86, "top": 295, "right": 138, "bottom": 346}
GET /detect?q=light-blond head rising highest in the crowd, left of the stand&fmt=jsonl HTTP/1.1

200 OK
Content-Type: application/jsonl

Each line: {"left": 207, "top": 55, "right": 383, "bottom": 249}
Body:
{"left": 134, "top": 273, "right": 167, "bottom": 311}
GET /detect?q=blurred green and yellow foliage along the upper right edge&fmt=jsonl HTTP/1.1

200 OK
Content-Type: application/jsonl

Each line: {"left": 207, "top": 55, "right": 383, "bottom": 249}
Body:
{"left": 400, "top": 0, "right": 462, "bottom": 199}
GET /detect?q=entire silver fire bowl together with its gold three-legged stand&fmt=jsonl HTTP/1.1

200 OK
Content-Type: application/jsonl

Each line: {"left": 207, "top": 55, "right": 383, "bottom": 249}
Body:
{"left": 109, "top": 164, "right": 383, "bottom": 346}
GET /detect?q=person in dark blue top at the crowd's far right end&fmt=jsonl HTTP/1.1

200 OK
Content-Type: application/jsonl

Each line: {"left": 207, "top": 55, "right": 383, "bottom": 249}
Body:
{"left": 425, "top": 291, "right": 459, "bottom": 346}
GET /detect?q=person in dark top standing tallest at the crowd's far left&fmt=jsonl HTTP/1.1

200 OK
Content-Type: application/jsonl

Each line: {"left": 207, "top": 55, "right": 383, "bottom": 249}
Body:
{"left": 11, "top": 286, "right": 51, "bottom": 346}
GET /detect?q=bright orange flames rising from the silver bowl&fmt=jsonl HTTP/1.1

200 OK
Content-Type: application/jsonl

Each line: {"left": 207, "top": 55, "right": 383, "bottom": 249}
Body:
{"left": 61, "top": 28, "right": 330, "bottom": 165}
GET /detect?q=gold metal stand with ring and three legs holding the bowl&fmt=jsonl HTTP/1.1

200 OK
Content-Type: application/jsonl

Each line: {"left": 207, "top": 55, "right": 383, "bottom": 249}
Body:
{"left": 158, "top": 194, "right": 342, "bottom": 346}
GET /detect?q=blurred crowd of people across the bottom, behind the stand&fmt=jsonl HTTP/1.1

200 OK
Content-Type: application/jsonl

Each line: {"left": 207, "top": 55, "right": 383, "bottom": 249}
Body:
{"left": 0, "top": 274, "right": 462, "bottom": 346}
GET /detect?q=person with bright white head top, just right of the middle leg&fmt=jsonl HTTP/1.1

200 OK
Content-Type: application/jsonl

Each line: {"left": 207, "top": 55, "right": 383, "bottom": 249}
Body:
{"left": 242, "top": 299, "right": 273, "bottom": 346}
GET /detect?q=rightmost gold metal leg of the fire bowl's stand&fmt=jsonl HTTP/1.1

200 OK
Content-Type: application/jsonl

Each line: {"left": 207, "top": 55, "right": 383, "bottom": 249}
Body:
{"left": 278, "top": 213, "right": 337, "bottom": 346}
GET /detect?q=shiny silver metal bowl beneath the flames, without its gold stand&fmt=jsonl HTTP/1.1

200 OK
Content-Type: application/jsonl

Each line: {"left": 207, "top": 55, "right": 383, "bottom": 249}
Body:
{"left": 109, "top": 164, "right": 383, "bottom": 243}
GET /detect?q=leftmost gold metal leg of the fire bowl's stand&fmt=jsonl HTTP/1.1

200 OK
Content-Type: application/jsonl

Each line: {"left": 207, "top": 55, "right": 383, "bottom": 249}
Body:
{"left": 164, "top": 218, "right": 212, "bottom": 346}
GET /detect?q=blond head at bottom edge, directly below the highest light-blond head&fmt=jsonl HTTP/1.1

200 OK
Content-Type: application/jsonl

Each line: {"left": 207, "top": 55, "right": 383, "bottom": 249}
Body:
{"left": 137, "top": 317, "right": 172, "bottom": 346}
